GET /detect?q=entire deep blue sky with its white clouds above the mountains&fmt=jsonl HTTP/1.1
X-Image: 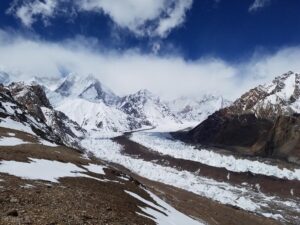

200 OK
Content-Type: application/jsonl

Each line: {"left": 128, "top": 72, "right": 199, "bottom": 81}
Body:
{"left": 0, "top": 0, "right": 300, "bottom": 96}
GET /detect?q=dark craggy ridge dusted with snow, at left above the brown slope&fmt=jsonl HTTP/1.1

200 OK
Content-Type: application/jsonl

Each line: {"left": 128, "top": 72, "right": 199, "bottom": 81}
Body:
{"left": 0, "top": 83, "right": 85, "bottom": 148}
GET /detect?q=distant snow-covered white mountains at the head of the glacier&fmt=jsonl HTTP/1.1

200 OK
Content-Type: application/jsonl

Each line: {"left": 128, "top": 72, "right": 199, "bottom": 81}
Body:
{"left": 3, "top": 73, "right": 226, "bottom": 137}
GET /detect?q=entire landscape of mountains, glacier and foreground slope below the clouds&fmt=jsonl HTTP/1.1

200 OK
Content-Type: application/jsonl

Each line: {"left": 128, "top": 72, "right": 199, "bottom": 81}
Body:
{"left": 0, "top": 73, "right": 300, "bottom": 225}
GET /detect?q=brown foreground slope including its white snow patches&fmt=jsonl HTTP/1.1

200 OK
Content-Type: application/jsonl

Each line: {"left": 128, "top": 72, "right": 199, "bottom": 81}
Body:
{"left": 0, "top": 127, "right": 202, "bottom": 225}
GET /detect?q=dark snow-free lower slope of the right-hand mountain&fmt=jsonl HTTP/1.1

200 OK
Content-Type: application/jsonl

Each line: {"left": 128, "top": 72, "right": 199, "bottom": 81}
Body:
{"left": 186, "top": 111, "right": 300, "bottom": 164}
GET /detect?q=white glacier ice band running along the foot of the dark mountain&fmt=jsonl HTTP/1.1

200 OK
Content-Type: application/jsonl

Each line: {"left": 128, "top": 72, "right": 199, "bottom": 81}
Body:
{"left": 130, "top": 132, "right": 300, "bottom": 180}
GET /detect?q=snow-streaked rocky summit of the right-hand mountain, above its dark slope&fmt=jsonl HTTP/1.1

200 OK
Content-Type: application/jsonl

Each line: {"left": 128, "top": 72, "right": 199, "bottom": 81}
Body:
{"left": 230, "top": 71, "right": 300, "bottom": 119}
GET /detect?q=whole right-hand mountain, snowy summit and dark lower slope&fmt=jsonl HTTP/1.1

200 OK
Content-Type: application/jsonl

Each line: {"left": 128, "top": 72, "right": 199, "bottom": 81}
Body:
{"left": 186, "top": 72, "right": 300, "bottom": 164}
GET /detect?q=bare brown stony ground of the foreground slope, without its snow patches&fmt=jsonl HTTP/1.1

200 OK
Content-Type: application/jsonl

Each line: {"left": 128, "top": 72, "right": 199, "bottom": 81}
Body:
{"left": 0, "top": 129, "right": 158, "bottom": 225}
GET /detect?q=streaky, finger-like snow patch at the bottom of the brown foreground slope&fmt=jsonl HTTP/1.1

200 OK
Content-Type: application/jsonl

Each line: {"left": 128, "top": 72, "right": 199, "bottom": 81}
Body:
{"left": 125, "top": 191, "right": 204, "bottom": 225}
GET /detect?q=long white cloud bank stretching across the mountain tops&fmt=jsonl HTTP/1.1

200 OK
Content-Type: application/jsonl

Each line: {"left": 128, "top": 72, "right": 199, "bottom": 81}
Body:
{"left": 0, "top": 30, "right": 300, "bottom": 99}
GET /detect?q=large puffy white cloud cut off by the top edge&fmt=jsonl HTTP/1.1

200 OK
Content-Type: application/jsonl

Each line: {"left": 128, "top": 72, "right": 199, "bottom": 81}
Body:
{"left": 9, "top": 0, "right": 193, "bottom": 37}
